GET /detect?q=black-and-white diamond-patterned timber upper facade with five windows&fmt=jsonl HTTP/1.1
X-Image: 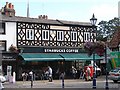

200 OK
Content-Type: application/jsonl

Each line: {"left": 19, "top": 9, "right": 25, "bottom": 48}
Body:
{"left": 17, "top": 22, "right": 96, "bottom": 47}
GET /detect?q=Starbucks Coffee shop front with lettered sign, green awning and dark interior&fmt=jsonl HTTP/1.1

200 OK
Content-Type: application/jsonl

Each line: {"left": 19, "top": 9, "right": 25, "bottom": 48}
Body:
{"left": 17, "top": 48, "right": 101, "bottom": 79}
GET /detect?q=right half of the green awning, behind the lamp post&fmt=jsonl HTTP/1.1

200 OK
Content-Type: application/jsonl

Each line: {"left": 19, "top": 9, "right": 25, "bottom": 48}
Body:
{"left": 60, "top": 53, "right": 103, "bottom": 61}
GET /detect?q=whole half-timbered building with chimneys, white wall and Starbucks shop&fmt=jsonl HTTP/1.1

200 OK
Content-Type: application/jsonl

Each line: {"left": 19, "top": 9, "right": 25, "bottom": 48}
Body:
{"left": 0, "top": 3, "right": 100, "bottom": 79}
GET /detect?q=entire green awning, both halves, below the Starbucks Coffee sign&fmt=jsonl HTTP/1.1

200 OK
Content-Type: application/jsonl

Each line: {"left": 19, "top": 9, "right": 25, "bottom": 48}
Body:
{"left": 20, "top": 53, "right": 103, "bottom": 61}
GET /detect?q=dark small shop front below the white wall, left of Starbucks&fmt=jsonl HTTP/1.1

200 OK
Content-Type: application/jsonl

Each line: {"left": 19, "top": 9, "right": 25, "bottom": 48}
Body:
{"left": 2, "top": 52, "right": 18, "bottom": 77}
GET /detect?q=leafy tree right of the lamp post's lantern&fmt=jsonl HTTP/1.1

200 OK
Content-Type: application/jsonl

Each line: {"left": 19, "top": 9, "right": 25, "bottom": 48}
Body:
{"left": 96, "top": 17, "right": 120, "bottom": 41}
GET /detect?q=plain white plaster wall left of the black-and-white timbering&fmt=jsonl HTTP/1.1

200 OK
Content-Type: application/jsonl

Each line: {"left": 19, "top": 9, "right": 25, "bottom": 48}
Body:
{"left": 0, "top": 22, "right": 16, "bottom": 51}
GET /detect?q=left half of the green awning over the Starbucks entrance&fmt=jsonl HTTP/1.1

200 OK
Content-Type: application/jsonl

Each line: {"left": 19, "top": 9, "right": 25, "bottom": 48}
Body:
{"left": 21, "top": 53, "right": 63, "bottom": 61}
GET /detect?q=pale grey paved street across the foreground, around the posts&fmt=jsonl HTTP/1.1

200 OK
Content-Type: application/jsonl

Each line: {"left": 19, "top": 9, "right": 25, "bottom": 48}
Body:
{"left": 3, "top": 76, "right": 120, "bottom": 90}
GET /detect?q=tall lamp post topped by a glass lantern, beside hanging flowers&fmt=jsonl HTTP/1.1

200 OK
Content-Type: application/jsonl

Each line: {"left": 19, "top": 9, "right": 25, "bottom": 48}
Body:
{"left": 90, "top": 14, "right": 97, "bottom": 89}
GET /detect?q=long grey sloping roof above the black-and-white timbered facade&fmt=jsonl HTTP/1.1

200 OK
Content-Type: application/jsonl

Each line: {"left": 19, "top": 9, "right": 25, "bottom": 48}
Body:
{"left": 0, "top": 15, "right": 92, "bottom": 26}
